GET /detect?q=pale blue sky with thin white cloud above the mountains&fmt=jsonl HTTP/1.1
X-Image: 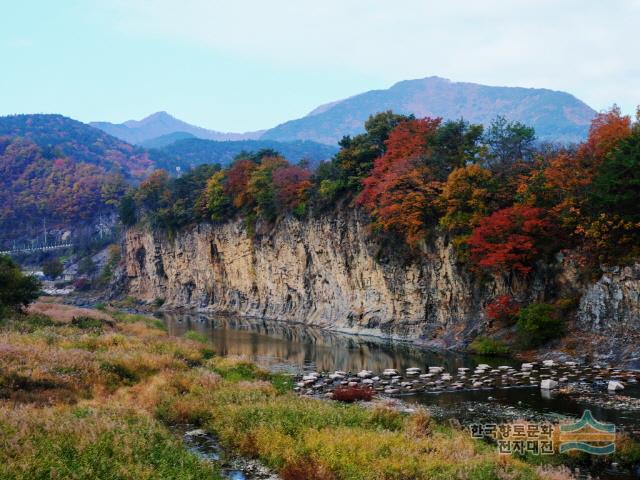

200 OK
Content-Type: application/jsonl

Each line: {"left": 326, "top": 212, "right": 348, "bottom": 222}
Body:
{"left": 0, "top": 0, "right": 640, "bottom": 131}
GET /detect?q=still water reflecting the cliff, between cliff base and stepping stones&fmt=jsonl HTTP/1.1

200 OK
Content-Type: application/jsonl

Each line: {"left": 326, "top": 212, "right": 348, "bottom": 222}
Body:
{"left": 165, "top": 314, "right": 504, "bottom": 372}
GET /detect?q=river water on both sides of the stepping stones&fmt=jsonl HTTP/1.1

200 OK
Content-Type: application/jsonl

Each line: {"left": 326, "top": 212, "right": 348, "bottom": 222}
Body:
{"left": 164, "top": 313, "right": 640, "bottom": 480}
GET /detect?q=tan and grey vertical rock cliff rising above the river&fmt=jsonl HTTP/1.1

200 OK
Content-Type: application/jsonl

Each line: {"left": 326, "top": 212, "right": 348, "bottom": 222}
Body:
{"left": 124, "top": 212, "right": 640, "bottom": 347}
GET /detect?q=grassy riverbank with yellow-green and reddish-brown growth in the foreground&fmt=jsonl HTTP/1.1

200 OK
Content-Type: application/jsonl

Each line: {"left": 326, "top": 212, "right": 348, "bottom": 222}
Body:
{"left": 0, "top": 304, "right": 592, "bottom": 480}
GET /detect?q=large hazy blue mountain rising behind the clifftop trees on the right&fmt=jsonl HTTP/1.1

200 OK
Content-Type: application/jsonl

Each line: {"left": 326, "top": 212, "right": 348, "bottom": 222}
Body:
{"left": 262, "top": 76, "right": 596, "bottom": 144}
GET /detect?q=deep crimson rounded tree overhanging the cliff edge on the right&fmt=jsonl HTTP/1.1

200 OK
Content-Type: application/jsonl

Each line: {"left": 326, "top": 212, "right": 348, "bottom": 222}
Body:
{"left": 467, "top": 205, "right": 553, "bottom": 275}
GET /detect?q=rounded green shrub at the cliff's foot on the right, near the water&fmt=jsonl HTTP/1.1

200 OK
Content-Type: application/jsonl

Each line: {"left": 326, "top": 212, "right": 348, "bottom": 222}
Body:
{"left": 517, "top": 303, "right": 564, "bottom": 345}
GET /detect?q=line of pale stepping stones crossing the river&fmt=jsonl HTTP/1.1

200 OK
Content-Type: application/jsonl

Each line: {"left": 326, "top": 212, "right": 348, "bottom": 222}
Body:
{"left": 294, "top": 360, "right": 640, "bottom": 397}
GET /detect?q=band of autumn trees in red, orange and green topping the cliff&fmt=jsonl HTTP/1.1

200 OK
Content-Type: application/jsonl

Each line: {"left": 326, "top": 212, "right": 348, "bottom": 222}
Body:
{"left": 124, "top": 108, "right": 640, "bottom": 276}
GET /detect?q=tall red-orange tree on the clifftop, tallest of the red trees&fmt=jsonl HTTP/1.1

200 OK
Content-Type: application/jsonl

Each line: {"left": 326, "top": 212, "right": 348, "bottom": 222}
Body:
{"left": 356, "top": 118, "right": 441, "bottom": 243}
